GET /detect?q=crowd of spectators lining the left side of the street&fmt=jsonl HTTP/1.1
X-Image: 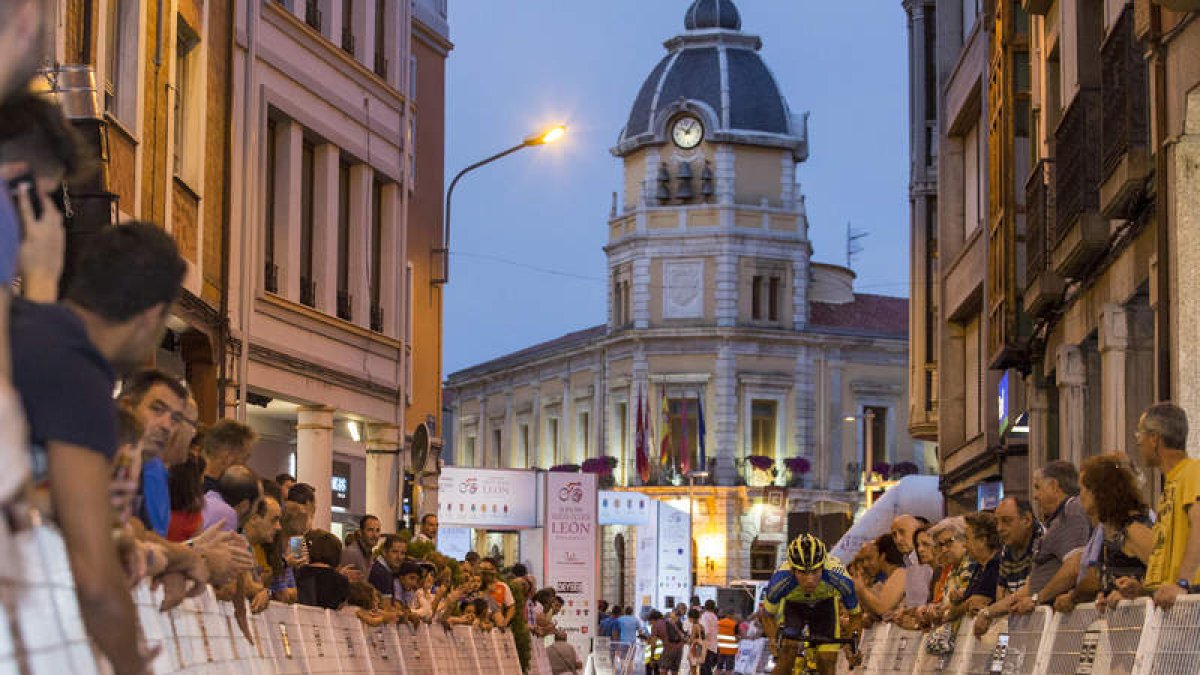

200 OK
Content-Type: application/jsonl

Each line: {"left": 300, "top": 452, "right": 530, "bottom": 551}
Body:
{"left": 0, "top": 0, "right": 583, "bottom": 675}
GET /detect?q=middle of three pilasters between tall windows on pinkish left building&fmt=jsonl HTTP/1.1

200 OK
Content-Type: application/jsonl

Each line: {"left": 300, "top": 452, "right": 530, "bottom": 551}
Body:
{"left": 312, "top": 143, "right": 343, "bottom": 315}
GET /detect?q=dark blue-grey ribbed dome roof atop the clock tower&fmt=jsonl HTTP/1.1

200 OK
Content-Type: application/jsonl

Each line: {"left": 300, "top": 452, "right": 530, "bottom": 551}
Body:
{"left": 613, "top": 0, "right": 808, "bottom": 161}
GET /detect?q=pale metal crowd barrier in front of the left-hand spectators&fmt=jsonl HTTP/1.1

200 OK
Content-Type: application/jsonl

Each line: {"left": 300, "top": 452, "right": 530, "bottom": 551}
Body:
{"left": 0, "top": 519, "right": 535, "bottom": 675}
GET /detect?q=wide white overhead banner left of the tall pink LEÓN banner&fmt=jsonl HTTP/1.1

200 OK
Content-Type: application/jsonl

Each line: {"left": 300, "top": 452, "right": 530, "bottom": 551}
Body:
{"left": 438, "top": 466, "right": 538, "bottom": 530}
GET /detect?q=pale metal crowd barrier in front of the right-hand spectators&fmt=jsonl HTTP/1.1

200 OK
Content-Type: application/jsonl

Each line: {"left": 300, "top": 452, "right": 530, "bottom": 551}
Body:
{"left": 838, "top": 596, "right": 1200, "bottom": 675}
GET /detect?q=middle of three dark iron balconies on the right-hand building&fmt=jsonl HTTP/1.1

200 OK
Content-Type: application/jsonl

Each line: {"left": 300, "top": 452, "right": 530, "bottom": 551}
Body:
{"left": 1054, "top": 89, "right": 1109, "bottom": 277}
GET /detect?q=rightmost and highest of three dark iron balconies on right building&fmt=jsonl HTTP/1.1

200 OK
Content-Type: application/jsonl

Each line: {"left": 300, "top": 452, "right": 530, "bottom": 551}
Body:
{"left": 1100, "top": 6, "right": 1152, "bottom": 219}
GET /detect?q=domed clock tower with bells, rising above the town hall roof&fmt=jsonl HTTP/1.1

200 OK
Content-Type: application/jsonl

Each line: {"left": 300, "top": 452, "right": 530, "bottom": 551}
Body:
{"left": 606, "top": 0, "right": 811, "bottom": 333}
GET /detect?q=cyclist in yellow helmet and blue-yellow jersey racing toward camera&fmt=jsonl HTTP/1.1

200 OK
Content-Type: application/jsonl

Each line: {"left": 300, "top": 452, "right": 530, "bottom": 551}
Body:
{"left": 763, "top": 534, "right": 863, "bottom": 675}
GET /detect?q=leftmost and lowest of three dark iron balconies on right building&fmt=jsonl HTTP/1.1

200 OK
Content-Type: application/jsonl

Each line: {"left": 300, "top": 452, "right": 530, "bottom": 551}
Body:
{"left": 1024, "top": 159, "right": 1063, "bottom": 318}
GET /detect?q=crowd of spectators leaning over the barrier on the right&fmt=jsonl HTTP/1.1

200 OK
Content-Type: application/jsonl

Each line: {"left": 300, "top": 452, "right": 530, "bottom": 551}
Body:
{"left": 847, "top": 402, "right": 1200, "bottom": 653}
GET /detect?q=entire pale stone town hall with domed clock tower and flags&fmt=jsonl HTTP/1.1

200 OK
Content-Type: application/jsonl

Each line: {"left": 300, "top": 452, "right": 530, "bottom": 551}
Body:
{"left": 445, "top": 0, "right": 916, "bottom": 603}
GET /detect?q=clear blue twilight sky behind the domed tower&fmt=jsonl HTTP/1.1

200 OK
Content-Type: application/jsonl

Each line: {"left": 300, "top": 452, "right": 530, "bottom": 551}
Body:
{"left": 444, "top": 0, "right": 908, "bottom": 374}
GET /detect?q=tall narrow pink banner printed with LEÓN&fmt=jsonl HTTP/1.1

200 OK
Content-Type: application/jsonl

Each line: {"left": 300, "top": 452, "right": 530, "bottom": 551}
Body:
{"left": 545, "top": 472, "right": 600, "bottom": 655}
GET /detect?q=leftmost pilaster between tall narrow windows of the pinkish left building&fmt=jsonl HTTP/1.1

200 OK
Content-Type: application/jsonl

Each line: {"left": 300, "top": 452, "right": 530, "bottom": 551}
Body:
{"left": 274, "top": 120, "right": 304, "bottom": 303}
